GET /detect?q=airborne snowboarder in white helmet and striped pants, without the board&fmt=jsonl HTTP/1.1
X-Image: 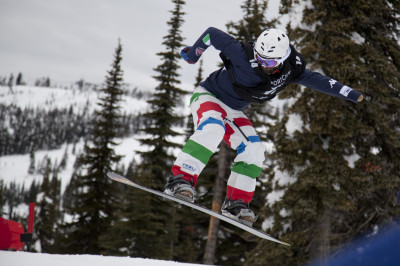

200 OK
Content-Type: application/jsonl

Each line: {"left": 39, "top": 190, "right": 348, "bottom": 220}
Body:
{"left": 164, "top": 27, "right": 363, "bottom": 226}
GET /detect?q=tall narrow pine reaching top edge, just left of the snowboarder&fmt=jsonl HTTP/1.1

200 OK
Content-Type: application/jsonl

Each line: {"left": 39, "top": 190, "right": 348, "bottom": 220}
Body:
{"left": 101, "top": 0, "right": 185, "bottom": 260}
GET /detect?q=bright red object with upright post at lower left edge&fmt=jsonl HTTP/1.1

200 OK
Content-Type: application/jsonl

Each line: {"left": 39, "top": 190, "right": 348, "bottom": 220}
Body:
{"left": 0, "top": 203, "right": 35, "bottom": 250}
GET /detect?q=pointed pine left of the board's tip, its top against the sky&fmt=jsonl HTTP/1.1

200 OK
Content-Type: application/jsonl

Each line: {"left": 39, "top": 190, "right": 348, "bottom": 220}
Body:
{"left": 62, "top": 41, "right": 124, "bottom": 254}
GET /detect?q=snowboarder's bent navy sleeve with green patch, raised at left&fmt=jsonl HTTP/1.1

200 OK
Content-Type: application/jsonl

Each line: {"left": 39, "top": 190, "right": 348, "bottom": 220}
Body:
{"left": 187, "top": 27, "right": 240, "bottom": 62}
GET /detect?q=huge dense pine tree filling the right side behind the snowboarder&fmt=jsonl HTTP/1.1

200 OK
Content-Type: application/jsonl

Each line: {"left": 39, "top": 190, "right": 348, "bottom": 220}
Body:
{"left": 248, "top": 1, "right": 400, "bottom": 265}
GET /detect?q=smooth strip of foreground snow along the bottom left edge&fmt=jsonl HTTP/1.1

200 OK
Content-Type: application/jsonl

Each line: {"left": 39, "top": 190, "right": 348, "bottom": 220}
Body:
{"left": 0, "top": 250, "right": 200, "bottom": 266}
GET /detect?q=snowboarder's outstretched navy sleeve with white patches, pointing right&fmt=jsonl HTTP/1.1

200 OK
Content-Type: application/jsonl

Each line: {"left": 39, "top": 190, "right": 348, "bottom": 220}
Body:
{"left": 294, "top": 69, "right": 362, "bottom": 103}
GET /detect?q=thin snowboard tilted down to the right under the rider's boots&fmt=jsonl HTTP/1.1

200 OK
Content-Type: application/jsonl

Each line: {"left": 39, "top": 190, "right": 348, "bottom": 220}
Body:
{"left": 107, "top": 172, "right": 290, "bottom": 246}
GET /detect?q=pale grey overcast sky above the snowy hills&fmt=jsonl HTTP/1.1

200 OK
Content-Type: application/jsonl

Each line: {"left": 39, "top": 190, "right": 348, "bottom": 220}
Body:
{"left": 0, "top": 0, "right": 279, "bottom": 90}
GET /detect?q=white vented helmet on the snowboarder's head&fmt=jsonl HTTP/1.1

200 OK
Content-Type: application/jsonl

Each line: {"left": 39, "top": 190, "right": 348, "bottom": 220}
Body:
{"left": 254, "top": 29, "right": 290, "bottom": 62}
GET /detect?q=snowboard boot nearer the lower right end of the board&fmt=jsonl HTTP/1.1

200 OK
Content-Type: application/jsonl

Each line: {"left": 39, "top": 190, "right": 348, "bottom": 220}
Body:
{"left": 221, "top": 199, "right": 258, "bottom": 227}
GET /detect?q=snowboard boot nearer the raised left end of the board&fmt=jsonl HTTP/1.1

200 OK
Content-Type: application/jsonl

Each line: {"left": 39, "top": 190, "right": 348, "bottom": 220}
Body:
{"left": 164, "top": 174, "right": 195, "bottom": 202}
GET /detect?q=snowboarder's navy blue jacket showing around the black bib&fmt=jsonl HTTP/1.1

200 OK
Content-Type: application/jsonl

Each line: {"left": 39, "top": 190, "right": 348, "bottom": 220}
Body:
{"left": 187, "top": 27, "right": 361, "bottom": 110}
